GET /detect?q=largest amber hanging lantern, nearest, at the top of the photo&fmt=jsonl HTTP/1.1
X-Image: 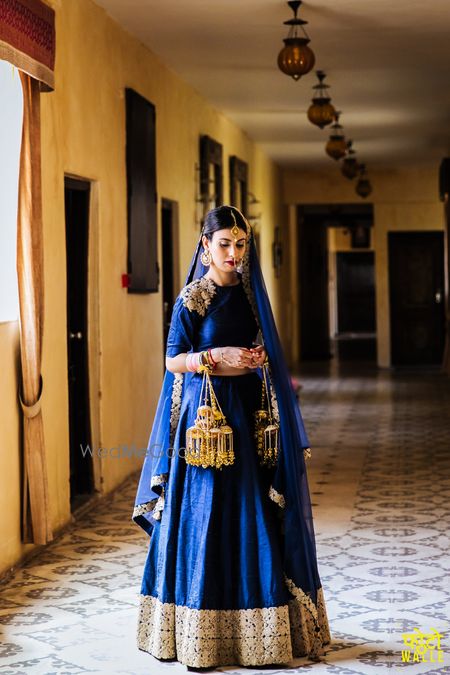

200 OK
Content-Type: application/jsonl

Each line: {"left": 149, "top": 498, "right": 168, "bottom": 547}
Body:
{"left": 278, "top": 0, "right": 316, "bottom": 80}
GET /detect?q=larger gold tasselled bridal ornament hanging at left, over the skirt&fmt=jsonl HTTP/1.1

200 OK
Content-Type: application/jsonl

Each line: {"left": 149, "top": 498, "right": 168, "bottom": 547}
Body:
{"left": 185, "top": 365, "right": 234, "bottom": 469}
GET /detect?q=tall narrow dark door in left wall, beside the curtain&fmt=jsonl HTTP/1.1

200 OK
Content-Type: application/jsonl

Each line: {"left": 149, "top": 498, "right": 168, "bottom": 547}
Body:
{"left": 65, "top": 178, "right": 93, "bottom": 509}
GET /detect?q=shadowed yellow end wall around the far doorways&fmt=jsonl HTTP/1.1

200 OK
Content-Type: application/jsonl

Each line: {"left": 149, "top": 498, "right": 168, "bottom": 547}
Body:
{"left": 283, "top": 166, "right": 444, "bottom": 367}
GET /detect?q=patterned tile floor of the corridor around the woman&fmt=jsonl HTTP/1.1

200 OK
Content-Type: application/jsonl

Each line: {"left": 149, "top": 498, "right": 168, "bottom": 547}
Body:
{"left": 0, "top": 364, "right": 450, "bottom": 675}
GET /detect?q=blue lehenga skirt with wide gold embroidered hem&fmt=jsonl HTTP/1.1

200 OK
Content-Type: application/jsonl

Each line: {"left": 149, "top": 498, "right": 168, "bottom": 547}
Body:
{"left": 138, "top": 373, "right": 327, "bottom": 667}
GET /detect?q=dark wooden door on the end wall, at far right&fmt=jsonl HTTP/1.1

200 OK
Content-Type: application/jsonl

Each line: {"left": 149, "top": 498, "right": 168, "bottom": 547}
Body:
{"left": 388, "top": 232, "right": 445, "bottom": 365}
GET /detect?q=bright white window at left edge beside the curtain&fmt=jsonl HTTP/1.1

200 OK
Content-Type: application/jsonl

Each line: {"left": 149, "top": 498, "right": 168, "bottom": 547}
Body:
{"left": 0, "top": 61, "right": 22, "bottom": 322}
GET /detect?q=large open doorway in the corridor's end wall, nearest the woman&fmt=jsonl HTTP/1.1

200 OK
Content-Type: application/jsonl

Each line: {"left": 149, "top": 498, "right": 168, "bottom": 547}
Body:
{"left": 297, "top": 204, "right": 376, "bottom": 361}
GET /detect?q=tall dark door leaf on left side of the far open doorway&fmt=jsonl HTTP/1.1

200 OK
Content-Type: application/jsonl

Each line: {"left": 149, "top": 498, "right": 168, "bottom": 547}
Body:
{"left": 297, "top": 209, "right": 331, "bottom": 360}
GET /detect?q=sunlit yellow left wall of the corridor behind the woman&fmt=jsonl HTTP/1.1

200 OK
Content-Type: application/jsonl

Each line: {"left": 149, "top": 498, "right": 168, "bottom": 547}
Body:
{"left": 0, "top": 0, "right": 284, "bottom": 571}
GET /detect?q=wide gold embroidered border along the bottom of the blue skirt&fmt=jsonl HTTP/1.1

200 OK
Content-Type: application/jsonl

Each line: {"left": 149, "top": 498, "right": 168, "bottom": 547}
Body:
{"left": 138, "top": 589, "right": 330, "bottom": 668}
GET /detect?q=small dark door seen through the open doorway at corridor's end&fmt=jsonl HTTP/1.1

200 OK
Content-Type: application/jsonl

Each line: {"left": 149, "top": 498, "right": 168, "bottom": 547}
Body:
{"left": 336, "top": 251, "right": 376, "bottom": 333}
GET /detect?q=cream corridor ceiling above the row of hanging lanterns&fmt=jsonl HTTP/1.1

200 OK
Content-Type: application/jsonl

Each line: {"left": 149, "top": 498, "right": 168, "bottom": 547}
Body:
{"left": 96, "top": 0, "right": 450, "bottom": 167}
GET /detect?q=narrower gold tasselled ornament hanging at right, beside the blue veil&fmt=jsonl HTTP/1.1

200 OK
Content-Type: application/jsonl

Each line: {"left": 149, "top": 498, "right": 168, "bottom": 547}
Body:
{"left": 254, "top": 361, "right": 280, "bottom": 468}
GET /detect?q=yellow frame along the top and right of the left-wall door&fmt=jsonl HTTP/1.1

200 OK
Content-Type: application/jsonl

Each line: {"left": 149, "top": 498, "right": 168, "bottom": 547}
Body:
{"left": 64, "top": 173, "right": 104, "bottom": 498}
